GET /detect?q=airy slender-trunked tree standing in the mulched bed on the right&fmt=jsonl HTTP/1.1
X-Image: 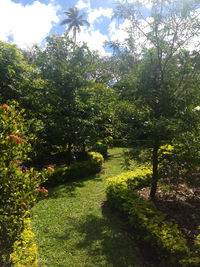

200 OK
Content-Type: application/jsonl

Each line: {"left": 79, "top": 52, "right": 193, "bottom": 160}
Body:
{"left": 115, "top": 0, "right": 200, "bottom": 199}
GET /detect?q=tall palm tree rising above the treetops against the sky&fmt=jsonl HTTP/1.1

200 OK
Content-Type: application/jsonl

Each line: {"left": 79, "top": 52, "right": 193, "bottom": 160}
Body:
{"left": 60, "top": 7, "right": 90, "bottom": 43}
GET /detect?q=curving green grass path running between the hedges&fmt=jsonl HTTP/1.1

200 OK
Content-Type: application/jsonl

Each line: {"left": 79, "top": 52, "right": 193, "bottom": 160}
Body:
{"left": 32, "top": 148, "right": 144, "bottom": 267}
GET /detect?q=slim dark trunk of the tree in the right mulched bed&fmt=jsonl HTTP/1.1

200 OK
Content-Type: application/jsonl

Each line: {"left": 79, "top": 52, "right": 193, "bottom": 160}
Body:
{"left": 150, "top": 135, "right": 159, "bottom": 200}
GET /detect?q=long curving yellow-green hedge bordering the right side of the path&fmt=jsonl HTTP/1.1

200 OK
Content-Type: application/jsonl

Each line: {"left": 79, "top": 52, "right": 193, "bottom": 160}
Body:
{"left": 106, "top": 167, "right": 200, "bottom": 266}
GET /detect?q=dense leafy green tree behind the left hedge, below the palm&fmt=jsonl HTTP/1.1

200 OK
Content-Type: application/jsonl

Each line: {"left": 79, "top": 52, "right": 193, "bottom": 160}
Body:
{"left": 30, "top": 34, "right": 112, "bottom": 163}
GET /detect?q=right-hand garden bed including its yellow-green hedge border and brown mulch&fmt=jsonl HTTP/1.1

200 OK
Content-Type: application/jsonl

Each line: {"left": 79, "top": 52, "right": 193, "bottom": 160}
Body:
{"left": 107, "top": 167, "right": 200, "bottom": 266}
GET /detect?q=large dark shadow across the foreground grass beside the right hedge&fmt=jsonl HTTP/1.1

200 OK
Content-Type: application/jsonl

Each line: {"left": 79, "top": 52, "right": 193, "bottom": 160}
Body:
{"left": 51, "top": 202, "right": 145, "bottom": 267}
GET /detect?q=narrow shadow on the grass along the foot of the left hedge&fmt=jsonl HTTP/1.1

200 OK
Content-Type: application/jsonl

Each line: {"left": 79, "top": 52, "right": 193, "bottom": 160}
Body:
{"left": 48, "top": 173, "right": 102, "bottom": 199}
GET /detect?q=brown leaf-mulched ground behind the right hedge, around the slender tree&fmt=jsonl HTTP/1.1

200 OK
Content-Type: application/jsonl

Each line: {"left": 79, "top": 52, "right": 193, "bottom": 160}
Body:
{"left": 138, "top": 183, "right": 200, "bottom": 250}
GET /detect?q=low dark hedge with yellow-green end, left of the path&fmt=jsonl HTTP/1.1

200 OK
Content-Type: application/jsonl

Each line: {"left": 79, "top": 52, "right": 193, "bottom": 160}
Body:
{"left": 45, "top": 152, "right": 104, "bottom": 186}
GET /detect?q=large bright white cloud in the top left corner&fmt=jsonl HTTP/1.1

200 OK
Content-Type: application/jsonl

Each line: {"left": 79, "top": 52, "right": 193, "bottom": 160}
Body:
{"left": 0, "top": 0, "right": 59, "bottom": 48}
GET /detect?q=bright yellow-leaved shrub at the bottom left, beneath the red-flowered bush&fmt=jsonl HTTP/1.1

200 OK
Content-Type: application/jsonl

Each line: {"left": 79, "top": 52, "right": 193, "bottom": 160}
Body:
{"left": 10, "top": 219, "right": 38, "bottom": 267}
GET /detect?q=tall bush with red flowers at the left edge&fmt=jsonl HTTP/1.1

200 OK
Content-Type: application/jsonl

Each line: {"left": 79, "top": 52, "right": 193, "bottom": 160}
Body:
{"left": 0, "top": 103, "right": 44, "bottom": 265}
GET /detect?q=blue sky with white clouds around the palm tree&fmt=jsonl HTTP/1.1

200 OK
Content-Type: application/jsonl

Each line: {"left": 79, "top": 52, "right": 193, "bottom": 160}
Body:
{"left": 0, "top": 0, "right": 199, "bottom": 56}
